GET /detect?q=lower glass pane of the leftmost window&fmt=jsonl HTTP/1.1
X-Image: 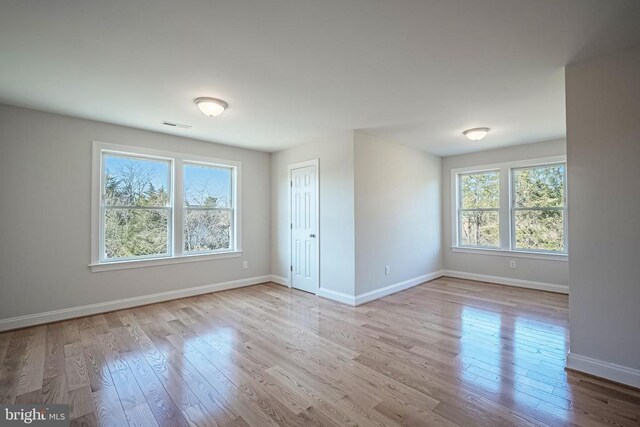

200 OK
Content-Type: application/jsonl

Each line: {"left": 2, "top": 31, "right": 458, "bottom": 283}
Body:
{"left": 104, "top": 208, "right": 169, "bottom": 260}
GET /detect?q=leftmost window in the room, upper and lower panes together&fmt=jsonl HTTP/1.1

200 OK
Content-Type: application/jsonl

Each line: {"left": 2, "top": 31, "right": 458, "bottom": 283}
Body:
{"left": 100, "top": 152, "right": 172, "bottom": 262}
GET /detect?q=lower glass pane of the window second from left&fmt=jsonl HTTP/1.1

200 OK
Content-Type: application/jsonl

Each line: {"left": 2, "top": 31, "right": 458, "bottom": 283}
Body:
{"left": 184, "top": 209, "right": 231, "bottom": 252}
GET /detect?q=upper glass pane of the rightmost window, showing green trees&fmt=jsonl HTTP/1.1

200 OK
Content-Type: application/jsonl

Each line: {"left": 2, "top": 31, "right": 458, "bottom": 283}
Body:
{"left": 514, "top": 165, "right": 565, "bottom": 208}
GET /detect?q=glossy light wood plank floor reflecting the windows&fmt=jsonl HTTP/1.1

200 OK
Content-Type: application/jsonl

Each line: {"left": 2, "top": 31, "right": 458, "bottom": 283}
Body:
{"left": 0, "top": 278, "right": 640, "bottom": 426}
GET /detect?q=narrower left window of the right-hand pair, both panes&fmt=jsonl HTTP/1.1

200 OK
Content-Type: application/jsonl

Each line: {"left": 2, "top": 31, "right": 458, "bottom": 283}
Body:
{"left": 458, "top": 170, "right": 500, "bottom": 248}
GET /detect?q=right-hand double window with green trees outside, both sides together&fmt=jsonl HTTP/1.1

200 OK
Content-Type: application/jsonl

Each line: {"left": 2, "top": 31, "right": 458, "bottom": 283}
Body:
{"left": 452, "top": 156, "right": 567, "bottom": 257}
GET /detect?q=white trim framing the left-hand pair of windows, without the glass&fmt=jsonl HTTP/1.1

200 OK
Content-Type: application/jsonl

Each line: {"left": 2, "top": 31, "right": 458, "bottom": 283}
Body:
{"left": 89, "top": 141, "right": 243, "bottom": 272}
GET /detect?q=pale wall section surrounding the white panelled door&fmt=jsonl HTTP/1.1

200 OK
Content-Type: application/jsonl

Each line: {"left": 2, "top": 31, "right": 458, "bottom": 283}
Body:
{"left": 271, "top": 131, "right": 355, "bottom": 295}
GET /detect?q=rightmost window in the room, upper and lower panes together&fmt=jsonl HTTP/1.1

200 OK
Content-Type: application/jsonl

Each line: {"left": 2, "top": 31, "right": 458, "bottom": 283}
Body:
{"left": 511, "top": 163, "right": 566, "bottom": 253}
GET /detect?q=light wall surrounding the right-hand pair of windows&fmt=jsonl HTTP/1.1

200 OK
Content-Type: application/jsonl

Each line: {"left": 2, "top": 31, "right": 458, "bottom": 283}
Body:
{"left": 442, "top": 140, "right": 573, "bottom": 286}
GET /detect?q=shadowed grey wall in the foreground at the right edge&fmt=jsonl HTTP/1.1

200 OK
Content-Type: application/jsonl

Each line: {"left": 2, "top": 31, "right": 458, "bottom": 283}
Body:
{"left": 566, "top": 47, "right": 640, "bottom": 387}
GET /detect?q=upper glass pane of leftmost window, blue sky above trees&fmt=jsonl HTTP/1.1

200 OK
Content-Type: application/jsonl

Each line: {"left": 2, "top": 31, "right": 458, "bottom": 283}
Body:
{"left": 103, "top": 154, "right": 171, "bottom": 206}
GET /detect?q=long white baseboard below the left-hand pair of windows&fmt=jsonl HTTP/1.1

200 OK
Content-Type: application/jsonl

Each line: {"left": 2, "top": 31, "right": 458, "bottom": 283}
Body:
{"left": 0, "top": 275, "right": 271, "bottom": 332}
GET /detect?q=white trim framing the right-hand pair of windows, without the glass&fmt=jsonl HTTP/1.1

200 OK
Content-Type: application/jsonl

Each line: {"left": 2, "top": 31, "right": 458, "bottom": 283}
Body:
{"left": 450, "top": 156, "right": 569, "bottom": 261}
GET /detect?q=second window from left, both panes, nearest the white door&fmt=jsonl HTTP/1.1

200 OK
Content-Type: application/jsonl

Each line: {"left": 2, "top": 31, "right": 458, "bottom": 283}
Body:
{"left": 183, "top": 163, "right": 234, "bottom": 254}
